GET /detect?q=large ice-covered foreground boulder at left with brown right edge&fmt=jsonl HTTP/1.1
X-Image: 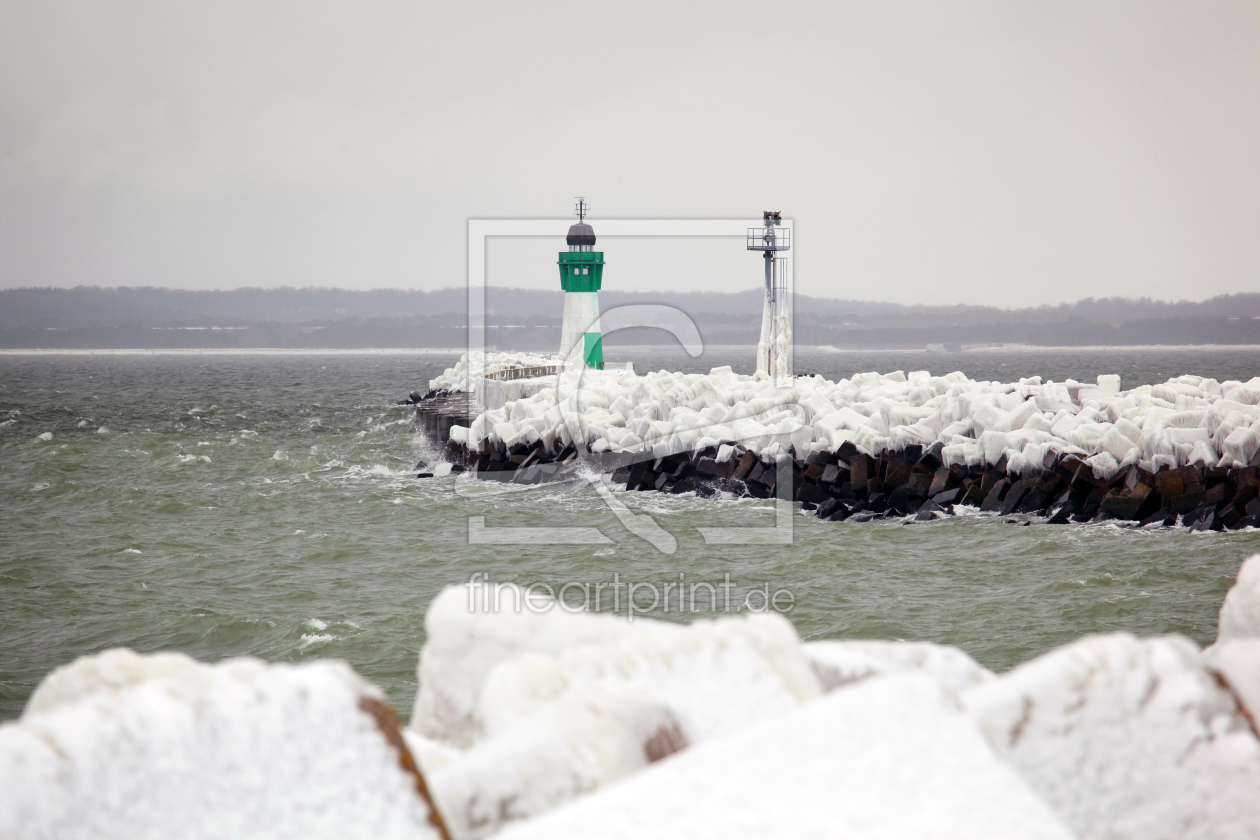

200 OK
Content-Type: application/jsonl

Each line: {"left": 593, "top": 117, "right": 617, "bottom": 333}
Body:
{"left": 0, "top": 651, "right": 440, "bottom": 840}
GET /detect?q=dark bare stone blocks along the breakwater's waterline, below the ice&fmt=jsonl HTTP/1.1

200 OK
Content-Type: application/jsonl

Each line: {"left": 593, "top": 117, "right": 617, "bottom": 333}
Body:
{"left": 417, "top": 418, "right": 1260, "bottom": 530}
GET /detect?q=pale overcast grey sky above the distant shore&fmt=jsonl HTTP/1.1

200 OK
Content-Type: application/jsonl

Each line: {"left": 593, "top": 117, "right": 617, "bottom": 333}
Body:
{"left": 0, "top": 0, "right": 1260, "bottom": 306}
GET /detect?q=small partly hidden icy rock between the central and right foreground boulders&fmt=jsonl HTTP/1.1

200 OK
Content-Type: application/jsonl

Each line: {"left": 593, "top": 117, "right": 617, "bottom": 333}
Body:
{"left": 801, "top": 641, "right": 994, "bottom": 694}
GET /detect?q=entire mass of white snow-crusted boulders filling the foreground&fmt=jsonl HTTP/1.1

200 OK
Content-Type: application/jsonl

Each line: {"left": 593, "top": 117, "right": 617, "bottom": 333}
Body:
{"left": 9, "top": 554, "right": 1260, "bottom": 840}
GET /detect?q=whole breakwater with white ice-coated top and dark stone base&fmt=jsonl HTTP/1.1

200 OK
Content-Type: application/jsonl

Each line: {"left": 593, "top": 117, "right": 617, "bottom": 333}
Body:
{"left": 415, "top": 354, "right": 1260, "bottom": 530}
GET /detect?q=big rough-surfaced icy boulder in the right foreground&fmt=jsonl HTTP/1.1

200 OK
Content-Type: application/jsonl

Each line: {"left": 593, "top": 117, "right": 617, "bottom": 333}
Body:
{"left": 963, "top": 633, "right": 1260, "bottom": 840}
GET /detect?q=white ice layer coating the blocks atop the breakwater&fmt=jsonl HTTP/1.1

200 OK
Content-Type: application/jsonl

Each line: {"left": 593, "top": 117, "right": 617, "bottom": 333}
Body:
{"left": 432, "top": 354, "right": 1260, "bottom": 479}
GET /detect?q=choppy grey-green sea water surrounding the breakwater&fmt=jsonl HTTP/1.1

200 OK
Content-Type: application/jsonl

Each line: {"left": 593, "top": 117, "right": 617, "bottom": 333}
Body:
{"left": 0, "top": 348, "right": 1260, "bottom": 719}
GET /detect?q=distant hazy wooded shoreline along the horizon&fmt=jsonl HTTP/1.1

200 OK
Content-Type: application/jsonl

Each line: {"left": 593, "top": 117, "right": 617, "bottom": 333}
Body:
{"left": 0, "top": 286, "right": 1260, "bottom": 350}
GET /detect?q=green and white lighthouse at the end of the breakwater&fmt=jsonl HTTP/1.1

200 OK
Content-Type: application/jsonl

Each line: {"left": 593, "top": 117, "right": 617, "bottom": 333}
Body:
{"left": 558, "top": 199, "right": 604, "bottom": 368}
